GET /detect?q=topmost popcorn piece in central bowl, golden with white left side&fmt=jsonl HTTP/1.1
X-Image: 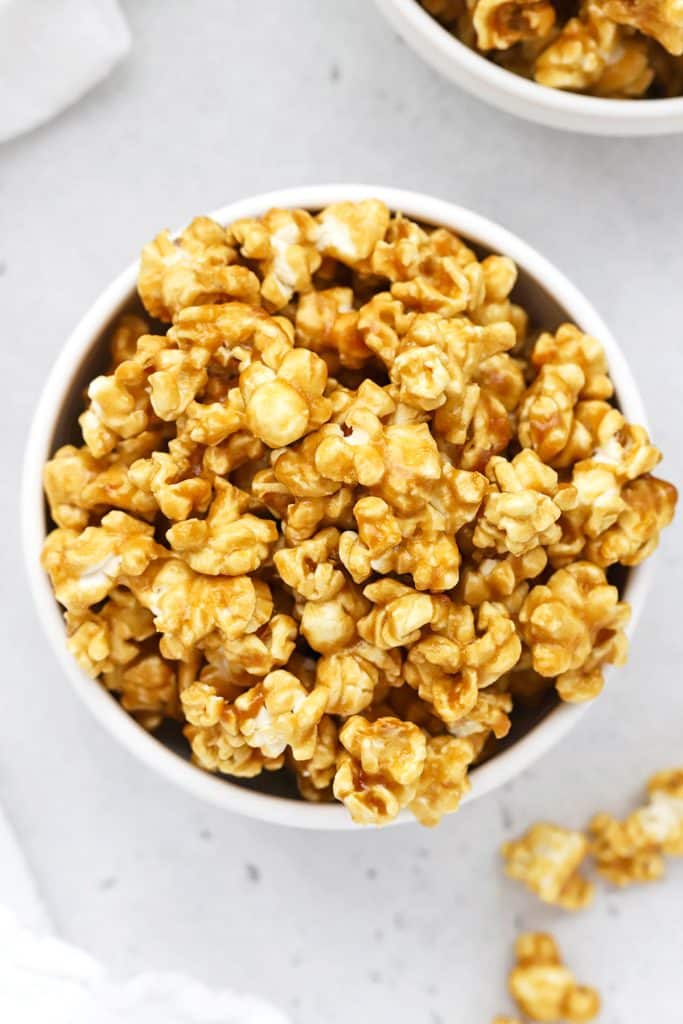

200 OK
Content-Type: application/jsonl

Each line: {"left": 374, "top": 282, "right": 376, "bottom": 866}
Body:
{"left": 315, "top": 199, "right": 389, "bottom": 266}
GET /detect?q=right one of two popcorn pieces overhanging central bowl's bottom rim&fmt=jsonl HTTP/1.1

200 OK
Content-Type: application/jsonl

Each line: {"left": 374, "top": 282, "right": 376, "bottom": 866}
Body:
{"left": 409, "top": 736, "right": 473, "bottom": 826}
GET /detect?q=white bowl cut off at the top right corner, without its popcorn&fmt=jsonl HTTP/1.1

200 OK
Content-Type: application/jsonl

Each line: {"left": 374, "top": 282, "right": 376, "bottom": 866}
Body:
{"left": 375, "top": 0, "right": 683, "bottom": 135}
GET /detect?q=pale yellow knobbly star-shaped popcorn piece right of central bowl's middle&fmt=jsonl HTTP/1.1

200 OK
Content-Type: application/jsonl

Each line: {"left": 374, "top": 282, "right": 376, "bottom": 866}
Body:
{"left": 473, "top": 449, "right": 577, "bottom": 555}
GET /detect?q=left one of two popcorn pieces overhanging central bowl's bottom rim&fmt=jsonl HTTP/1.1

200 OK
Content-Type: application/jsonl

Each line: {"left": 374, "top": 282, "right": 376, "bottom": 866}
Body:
{"left": 334, "top": 715, "right": 427, "bottom": 824}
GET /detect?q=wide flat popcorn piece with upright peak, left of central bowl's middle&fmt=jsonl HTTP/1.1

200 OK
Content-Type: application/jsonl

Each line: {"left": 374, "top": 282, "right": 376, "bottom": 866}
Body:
{"left": 166, "top": 479, "right": 279, "bottom": 575}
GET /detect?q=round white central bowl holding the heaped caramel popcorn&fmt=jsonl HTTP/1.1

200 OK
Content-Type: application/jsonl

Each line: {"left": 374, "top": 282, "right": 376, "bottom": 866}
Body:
{"left": 22, "top": 184, "right": 649, "bottom": 829}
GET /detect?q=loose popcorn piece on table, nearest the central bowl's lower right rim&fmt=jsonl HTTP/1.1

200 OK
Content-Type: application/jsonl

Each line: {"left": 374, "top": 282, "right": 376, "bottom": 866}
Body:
{"left": 502, "top": 822, "right": 595, "bottom": 910}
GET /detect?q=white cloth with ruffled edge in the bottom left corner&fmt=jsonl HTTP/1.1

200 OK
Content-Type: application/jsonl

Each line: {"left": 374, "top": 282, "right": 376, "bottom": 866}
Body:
{"left": 0, "top": 807, "right": 288, "bottom": 1024}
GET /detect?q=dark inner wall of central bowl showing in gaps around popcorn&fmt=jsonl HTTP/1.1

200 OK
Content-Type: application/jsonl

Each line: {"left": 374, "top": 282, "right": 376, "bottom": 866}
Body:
{"left": 43, "top": 201, "right": 628, "bottom": 811}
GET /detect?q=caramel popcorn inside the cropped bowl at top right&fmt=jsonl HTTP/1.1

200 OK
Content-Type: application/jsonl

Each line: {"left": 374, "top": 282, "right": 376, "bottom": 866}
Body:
{"left": 420, "top": 0, "right": 683, "bottom": 99}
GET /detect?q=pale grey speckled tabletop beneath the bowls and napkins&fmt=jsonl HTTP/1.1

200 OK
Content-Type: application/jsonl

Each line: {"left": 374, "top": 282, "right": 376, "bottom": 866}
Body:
{"left": 0, "top": 0, "right": 683, "bottom": 1024}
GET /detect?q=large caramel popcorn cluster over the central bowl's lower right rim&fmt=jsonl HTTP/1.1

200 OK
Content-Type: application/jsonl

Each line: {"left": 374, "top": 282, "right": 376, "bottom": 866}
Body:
{"left": 519, "top": 561, "right": 630, "bottom": 702}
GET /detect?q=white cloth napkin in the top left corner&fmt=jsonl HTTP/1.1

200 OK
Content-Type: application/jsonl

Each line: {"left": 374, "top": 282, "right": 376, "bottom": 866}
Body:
{"left": 0, "top": 0, "right": 130, "bottom": 142}
